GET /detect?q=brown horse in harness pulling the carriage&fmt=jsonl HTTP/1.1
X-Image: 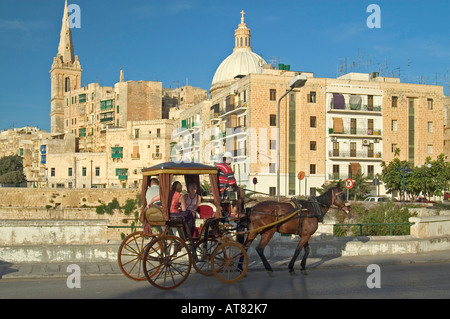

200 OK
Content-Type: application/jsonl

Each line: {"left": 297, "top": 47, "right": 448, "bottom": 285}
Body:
{"left": 244, "top": 186, "right": 350, "bottom": 274}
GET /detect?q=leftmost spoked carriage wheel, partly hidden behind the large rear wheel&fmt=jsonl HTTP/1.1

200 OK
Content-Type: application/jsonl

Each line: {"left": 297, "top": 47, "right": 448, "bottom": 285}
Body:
{"left": 117, "top": 231, "right": 153, "bottom": 281}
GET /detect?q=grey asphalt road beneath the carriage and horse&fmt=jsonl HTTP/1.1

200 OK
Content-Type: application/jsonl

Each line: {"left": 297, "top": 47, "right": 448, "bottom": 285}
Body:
{"left": 0, "top": 262, "right": 450, "bottom": 303}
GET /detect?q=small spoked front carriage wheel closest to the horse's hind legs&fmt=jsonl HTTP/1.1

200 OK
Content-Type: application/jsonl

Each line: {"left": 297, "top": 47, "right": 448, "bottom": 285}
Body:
{"left": 211, "top": 241, "right": 248, "bottom": 284}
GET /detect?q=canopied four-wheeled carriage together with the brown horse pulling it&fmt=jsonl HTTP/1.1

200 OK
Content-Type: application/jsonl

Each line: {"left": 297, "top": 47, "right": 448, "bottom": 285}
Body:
{"left": 118, "top": 162, "right": 346, "bottom": 289}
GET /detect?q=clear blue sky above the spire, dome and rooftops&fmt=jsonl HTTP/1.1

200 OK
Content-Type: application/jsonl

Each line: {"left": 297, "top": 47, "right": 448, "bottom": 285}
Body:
{"left": 0, "top": 0, "right": 450, "bottom": 131}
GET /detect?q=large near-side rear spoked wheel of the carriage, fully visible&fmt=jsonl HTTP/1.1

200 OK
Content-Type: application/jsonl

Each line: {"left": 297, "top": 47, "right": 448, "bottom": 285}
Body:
{"left": 143, "top": 235, "right": 192, "bottom": 289}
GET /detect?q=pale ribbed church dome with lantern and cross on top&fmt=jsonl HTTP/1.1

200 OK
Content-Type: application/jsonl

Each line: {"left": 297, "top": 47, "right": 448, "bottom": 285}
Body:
{"left": 210, "top": 11, "right": 266, "bottom": 92}
